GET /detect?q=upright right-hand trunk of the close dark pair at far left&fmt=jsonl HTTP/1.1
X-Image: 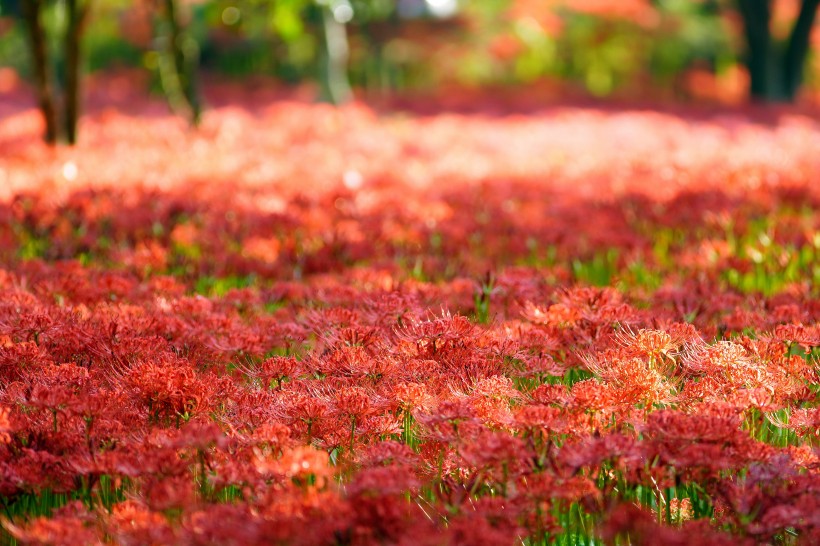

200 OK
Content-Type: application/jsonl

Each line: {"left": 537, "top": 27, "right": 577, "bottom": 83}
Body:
{"left": 63, "top": 0, "right": 88, "bottom": 145}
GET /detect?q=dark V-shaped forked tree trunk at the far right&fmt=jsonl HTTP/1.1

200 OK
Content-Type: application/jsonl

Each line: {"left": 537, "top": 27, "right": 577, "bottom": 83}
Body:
{"left": 737, "top": 0, "right": 820, "bottom": 101}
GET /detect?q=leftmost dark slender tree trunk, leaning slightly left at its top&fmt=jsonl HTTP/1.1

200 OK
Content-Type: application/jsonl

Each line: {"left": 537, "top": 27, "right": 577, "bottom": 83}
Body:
{"left": 22, "top": 0, "right": 58, "bottom": 144}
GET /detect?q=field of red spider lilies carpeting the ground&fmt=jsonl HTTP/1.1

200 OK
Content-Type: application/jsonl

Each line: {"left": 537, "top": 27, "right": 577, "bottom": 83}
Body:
{"left": 0, "top": 77, "right": 820, "bottom": 545}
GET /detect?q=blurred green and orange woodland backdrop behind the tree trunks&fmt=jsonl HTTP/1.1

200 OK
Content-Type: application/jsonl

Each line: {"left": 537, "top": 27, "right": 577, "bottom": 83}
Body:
{"left": 0, "top": 0, "right": 820, "bottom": 108}
